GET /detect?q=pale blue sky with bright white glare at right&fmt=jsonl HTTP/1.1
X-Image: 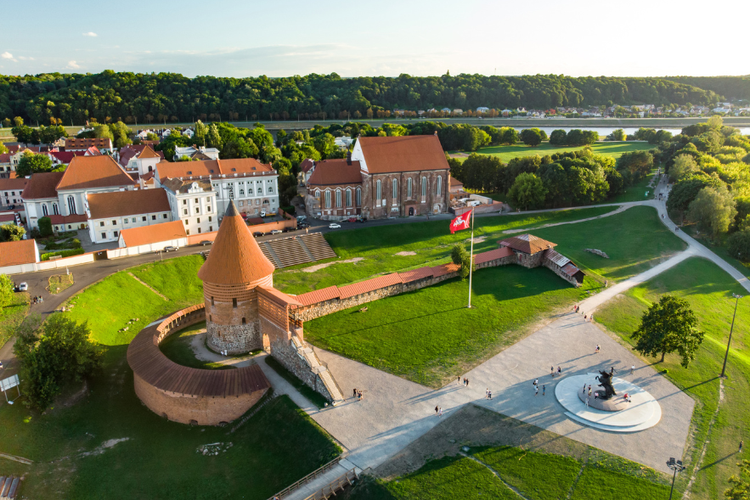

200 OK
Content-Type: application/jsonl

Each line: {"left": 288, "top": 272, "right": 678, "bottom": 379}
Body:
{"left": 0, "top": 0, "right": 750, "bottom": 77}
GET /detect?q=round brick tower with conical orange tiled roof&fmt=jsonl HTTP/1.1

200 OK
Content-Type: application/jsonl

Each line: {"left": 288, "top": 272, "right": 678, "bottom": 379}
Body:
{"left": 198, "top": 202, "right": 275, "bottom": 354}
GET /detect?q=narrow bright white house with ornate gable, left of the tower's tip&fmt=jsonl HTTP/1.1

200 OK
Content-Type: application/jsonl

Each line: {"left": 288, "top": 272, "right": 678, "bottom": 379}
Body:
{"left": 161, "top": 177, "right": 219, "bottom": 236}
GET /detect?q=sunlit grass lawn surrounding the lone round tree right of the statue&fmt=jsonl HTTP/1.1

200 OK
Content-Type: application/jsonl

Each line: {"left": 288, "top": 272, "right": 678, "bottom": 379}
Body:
{"left": 597, "top": 258, "right": 750, "bottom": 499}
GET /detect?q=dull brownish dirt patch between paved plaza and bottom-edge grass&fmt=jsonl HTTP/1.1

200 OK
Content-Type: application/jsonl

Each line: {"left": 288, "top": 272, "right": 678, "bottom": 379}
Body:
{"left": 375, "top": 404, "right": 589, "bottom": 480}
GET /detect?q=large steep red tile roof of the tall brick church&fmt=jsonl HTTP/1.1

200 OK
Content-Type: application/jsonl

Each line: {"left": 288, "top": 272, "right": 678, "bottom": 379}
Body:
{"left": 357, "top": 135, "right": 450, "bottom": 174}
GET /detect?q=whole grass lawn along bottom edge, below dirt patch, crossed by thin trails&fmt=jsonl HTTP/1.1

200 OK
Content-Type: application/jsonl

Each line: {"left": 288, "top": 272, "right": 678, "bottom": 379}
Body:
{"left": 345, "top": 446, "right": 669, "bottom": 500}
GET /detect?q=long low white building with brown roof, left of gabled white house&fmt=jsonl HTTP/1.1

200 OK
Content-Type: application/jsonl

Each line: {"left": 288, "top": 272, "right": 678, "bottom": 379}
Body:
{"left": 86, "top": 189, "right": 173, "bottom": 243}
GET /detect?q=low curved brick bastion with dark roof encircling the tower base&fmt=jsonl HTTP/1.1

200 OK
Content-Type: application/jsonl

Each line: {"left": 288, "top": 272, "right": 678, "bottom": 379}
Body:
{"left": 127, "top": 304, "right": 270, "bottom": 425}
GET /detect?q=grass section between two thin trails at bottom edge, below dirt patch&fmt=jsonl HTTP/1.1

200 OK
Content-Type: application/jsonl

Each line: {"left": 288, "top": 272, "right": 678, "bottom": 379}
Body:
{"left": 472, "top": 446, "right": 581, "bottom": 500}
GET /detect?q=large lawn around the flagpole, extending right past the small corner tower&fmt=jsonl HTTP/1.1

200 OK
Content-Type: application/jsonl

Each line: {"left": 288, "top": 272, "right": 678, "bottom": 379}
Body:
{"left": 305, "top": 207, "right": 685, "bottom": 387}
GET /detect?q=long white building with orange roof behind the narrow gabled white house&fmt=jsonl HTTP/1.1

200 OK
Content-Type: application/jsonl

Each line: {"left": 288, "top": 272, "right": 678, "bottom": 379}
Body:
{"left": 156, "top": 158, "right": 279, "bottom": 216}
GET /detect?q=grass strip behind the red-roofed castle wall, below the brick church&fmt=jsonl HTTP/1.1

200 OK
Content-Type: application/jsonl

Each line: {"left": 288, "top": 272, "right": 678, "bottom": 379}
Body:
{"left": 274, "top": 207, "right": 615, "bottom": 294}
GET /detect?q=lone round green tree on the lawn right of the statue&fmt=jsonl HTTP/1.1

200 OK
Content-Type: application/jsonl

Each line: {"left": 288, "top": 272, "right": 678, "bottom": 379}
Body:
{"left": 632, "top": 295, "right": 703, "bottom": 368}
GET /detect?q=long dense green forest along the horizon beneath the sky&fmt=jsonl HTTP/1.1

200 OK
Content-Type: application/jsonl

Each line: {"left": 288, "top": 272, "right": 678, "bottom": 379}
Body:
{"left": 0, "top": 70, "right": 750, "bottom": 125}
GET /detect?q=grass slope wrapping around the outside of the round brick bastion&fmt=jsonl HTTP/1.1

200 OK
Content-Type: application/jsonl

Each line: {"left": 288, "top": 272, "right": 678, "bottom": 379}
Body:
{"left": 0, "top": 256, "right": 340, "bottom": 500}
